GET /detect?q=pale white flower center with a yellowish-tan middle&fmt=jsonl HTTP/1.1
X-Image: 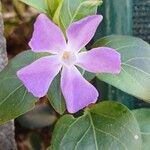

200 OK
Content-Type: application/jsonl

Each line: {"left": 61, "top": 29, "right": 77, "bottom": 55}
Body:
{"left": 61, "top": 51, "right": 77, "bottom": 66}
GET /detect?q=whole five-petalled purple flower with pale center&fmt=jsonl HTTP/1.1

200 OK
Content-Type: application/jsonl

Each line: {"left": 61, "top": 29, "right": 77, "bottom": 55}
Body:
{"left": 17, "top": 14, "right": 121, "bottom": 113}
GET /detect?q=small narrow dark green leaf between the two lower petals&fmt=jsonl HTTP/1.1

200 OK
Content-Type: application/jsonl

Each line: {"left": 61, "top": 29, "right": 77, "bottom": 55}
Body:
{"left": 47, "top": 74, "right": 66, "bottom": 114}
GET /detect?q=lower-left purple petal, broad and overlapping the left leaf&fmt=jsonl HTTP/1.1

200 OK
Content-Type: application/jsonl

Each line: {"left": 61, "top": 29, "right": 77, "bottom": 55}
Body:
{"left": 17, "top": 56, "right": 61, "bottom": 97}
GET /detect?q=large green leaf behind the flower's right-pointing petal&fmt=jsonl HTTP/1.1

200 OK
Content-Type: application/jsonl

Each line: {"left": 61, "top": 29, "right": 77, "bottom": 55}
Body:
{"left": 93, "top": 35, "right": 150, "bottom": 101}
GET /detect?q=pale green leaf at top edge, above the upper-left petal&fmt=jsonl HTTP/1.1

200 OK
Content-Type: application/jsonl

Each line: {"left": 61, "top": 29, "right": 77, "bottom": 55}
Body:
{"left": 20, "top": 0, "right": 47, "bottom": 13}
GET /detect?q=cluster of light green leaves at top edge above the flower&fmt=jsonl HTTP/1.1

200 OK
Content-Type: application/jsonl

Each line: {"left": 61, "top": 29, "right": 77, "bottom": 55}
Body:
{"left": 20, "top": 0, "right": 102, "bottom": 31}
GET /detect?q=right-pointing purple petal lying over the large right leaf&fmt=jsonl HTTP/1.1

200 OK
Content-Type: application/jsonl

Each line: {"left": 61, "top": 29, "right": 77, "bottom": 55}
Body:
{"left": 77, "top": 47, "right": 121, "bottom": 74}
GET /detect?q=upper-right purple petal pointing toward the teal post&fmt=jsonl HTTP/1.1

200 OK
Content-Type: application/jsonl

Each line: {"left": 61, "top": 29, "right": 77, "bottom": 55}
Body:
{"left": 67, "top": 15, "right": 103, "bottom": 51}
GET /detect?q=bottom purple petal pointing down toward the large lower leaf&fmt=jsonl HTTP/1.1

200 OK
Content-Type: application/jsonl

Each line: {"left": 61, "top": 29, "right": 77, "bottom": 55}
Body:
{"left": 61, "top": 66, "right": 98, "bottom": 113}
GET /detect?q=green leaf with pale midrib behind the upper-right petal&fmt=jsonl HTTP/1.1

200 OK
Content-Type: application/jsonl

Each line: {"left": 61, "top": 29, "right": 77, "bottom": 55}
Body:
{"left": 60, "top": 0, "right": 102, "bottom": 30}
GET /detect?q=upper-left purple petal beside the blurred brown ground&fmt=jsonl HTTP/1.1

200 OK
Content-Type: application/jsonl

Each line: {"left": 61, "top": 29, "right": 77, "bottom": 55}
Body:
{"left": 29, "top": 14, "right": 66, "bottom": 53}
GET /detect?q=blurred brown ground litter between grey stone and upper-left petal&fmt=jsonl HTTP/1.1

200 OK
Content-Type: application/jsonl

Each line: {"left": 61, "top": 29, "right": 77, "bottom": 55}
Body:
{"left": 2, "top": 0, "right": 37, "bottom": 58}
